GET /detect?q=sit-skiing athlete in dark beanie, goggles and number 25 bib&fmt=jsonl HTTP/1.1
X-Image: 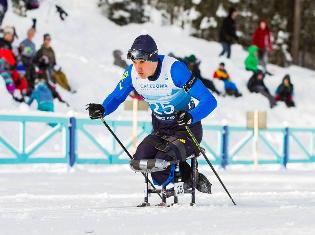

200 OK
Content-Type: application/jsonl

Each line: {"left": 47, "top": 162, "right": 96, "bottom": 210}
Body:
{"left": 88, "top": 35, "right": 217, "bottom": 193}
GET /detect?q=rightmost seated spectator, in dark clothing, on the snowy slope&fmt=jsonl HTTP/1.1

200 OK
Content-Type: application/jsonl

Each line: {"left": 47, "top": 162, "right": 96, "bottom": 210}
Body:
{"left": 276, "top": 74, "right": 295, "bottom": 108}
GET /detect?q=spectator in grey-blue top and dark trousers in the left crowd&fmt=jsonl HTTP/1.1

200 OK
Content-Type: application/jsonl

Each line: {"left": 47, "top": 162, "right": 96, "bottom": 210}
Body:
{"left": 19, "top": 19, "right": 36, "bottom": 89}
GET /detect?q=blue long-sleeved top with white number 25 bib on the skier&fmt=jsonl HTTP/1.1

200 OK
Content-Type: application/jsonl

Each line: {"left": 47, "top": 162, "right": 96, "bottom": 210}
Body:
{"left": 102, "top": 55, "right": 217, "bottom": 124}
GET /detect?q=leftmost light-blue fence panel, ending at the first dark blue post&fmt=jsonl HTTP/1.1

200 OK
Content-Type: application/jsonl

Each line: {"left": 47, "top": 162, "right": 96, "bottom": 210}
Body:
{"left": 0, "top": 115, "right": 70, "bottom": 164}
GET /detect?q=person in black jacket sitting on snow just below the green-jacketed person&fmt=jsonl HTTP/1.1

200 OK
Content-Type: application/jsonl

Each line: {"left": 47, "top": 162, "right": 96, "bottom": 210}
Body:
{"left": 247, "top": 70, "right": 276, "bottom": 108}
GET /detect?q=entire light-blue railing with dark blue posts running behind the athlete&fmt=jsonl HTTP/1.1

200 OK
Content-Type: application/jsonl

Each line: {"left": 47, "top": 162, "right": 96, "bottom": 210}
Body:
{"left": 0, "top": 114, "right": 315, "bottom": 168}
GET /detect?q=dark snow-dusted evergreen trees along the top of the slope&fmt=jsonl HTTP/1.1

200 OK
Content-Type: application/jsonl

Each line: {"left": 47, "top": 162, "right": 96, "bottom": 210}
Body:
{"left": 101, "top": 0, "right": 315, "bottom": 68}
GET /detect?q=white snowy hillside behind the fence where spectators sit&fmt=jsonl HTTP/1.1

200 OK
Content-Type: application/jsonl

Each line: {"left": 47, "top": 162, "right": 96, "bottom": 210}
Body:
{"left": 0, "top": 0, "right": 315, "bottom": 129}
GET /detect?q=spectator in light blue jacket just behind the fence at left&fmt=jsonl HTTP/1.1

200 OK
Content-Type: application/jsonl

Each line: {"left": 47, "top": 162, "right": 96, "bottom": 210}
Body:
{"left": 27, "top": 78, "right": 54, "bottom": 112}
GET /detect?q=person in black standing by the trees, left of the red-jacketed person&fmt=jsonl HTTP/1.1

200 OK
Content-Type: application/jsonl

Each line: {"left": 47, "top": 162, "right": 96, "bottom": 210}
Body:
{"left": 219, "top": 8, "right": 238, "bottom": 58}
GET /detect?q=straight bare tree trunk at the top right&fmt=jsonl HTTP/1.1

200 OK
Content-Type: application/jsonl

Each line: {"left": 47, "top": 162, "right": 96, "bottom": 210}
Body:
{"left": 292, "top": 0, "right": 303, "bottom": 64}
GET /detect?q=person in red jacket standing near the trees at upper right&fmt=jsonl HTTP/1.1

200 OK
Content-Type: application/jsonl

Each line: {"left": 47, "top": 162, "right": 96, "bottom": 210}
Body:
{"left": 252, "top": 20, "right": 272, "bottom": 74}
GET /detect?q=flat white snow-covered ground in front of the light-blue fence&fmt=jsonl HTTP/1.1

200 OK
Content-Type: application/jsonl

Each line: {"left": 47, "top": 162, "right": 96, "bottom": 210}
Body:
{"left": 0, "top": 165, "right": 315, "bottom": 235}
